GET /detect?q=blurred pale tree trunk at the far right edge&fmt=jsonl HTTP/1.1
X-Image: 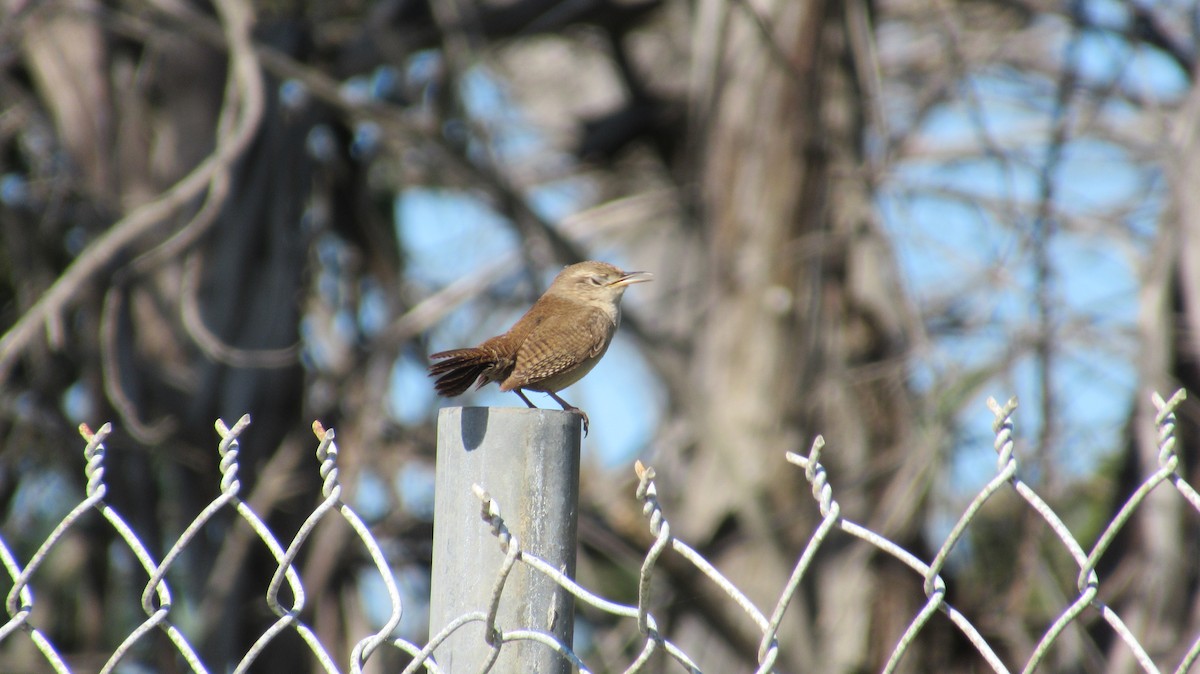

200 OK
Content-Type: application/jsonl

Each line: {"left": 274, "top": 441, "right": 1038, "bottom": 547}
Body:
{"left": 1093, "top": 72, "right": 1200, "bottom": 673}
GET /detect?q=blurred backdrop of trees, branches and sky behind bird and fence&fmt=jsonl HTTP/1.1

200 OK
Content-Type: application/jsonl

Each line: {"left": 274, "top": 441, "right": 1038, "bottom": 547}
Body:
{"left": 0, "top": 0, "right": 1200, "bottom": 672}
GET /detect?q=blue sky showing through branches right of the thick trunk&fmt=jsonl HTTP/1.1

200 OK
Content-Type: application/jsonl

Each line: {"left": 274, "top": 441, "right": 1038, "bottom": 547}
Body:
{"left": 878, "top": 14, "right": 1187, "bottom": 485}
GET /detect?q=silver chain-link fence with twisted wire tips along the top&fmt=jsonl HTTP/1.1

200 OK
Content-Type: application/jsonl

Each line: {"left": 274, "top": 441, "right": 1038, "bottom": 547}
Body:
{"left": 0, "top": 391, "right": 1200, "bottom": 674}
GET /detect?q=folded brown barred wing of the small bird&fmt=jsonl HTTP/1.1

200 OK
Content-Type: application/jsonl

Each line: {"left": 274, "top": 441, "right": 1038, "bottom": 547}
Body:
{"left": 502, "top": 304, "right": 617, "bottom": 391}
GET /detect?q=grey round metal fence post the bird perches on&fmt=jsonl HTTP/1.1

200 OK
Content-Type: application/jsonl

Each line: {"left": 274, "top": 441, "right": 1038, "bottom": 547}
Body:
{"left": 430, "top": 408, "right": 580, "bottom": 674}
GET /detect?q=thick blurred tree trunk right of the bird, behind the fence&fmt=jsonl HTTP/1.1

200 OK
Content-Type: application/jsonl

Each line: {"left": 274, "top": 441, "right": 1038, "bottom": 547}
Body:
{"left": 674, "top": 0, "right": 955, "bottom": 672}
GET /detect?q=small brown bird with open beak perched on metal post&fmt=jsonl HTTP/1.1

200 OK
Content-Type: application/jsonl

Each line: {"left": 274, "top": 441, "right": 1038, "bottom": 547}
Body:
{"left": 430, "top": 261, "right": 653, "bottom": 435}
